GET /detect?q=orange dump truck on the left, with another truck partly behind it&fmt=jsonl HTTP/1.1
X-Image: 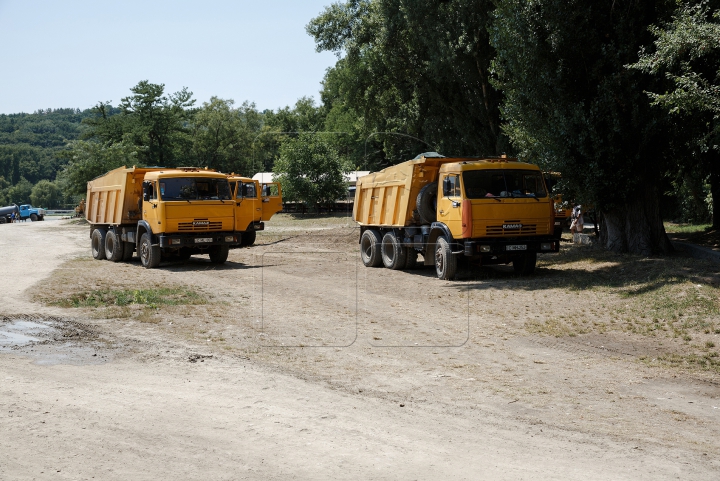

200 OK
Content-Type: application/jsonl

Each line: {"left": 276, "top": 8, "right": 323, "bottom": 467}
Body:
{"left": 85, "top": 167, "right": 239, "bottom": 268}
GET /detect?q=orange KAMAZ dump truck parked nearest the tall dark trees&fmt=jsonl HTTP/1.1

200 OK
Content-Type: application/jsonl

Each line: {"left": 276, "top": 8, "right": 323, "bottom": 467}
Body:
{"left": 353, "top": 152, "right": 559, "bottom": 279}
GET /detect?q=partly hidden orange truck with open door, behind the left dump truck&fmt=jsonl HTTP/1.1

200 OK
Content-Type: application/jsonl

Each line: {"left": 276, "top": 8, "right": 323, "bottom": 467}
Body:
{"left": 228, "top": 174, "right": 283, "bottom": 247}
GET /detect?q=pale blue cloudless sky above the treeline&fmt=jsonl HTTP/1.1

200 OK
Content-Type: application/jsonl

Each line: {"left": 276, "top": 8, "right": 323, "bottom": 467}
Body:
{"left": 0, "top": 0, "right": 336, "bottom": 114}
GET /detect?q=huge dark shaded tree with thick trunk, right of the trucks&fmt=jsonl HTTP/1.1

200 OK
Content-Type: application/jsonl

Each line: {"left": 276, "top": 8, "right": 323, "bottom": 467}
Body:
{"left": 492, "top": 0, "right": 677, "bottom": 255}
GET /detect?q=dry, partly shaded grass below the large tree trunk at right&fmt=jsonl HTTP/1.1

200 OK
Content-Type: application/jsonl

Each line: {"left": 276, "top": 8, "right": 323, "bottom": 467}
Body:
{"left": 525, "top": 236, "right": 720, "bottom": 372}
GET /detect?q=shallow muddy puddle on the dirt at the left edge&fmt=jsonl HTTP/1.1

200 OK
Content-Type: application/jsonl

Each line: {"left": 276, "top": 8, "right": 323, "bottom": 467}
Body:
{"left": 0, "top": 315, "right": 113, "bottom": 365}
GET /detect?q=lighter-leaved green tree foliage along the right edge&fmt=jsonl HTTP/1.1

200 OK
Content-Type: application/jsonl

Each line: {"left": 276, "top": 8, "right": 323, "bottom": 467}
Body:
{"left": 629, "top": 1, "right": 720, "bottom": 228}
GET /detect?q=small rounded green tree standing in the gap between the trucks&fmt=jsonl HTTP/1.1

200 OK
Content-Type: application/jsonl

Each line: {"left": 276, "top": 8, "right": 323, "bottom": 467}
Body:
{"left": 273, "top": 134, "right": 347, "bottom": 208}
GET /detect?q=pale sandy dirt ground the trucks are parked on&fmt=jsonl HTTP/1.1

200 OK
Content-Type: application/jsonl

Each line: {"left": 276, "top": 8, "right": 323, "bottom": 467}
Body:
{"left": 0, "top": 221, "right": 720, "bottom": 480}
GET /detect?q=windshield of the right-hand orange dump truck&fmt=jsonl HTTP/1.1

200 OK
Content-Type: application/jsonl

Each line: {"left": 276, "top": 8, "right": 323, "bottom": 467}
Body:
{"left": 463, "top": 170, "right": 547, "bottom": 199}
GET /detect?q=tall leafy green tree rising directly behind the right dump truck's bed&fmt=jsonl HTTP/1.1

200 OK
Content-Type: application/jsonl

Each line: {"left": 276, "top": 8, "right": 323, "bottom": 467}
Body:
{"left": 307, "top": 0, "right": 507, "bottom": 167}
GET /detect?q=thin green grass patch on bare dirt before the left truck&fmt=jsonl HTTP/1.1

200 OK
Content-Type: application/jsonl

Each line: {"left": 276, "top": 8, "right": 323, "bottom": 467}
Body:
{"left": 52, "top": 287, "right": 207, "bottom": 308}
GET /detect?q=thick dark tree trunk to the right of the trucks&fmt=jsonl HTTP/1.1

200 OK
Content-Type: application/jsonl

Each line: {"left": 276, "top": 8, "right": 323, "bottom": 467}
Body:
{"left": 600, "top": 185, "right": 673, "bottom": 256}
